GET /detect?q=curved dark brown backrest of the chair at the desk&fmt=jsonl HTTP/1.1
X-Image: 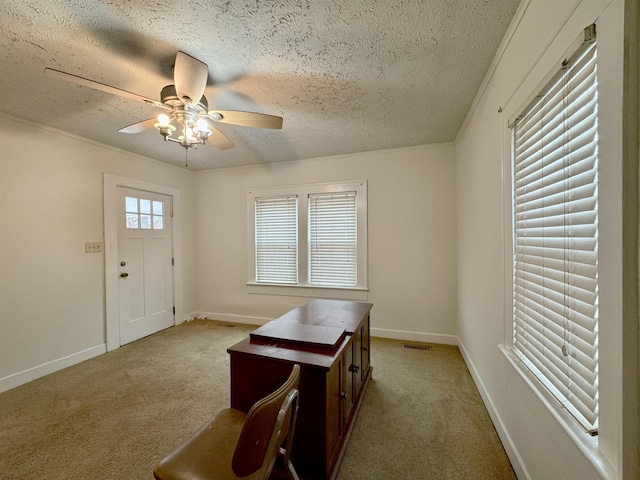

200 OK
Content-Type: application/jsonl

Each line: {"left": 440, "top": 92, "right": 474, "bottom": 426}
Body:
{"left": 231, "top": 365, "right": 300, "bottom": 479}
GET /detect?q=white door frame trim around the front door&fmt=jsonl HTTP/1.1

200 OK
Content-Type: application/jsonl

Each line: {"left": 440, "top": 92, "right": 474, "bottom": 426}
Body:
{"left": 103, "top": 173, "right": 183, "bottom": 351}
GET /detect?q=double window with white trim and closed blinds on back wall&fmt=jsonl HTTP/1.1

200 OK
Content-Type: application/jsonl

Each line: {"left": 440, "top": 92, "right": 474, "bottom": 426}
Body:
{"left": 248, "top": 181, "right": 367, "bottom": 290}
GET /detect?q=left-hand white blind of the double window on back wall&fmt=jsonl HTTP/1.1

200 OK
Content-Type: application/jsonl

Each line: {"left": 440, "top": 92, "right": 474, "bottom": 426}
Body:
{"left": 255, "top": 196, "right": 298, "bottom": 284}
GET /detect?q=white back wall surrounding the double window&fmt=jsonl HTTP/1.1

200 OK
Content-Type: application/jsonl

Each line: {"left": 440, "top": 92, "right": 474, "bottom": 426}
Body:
{"left": 196, "top": 143, "right": 457, "bottom": 343}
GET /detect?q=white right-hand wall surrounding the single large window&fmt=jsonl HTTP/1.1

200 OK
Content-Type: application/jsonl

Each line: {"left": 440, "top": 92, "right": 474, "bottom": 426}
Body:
{"left": 456, "top": 0, "right": 637, "bottom": 480}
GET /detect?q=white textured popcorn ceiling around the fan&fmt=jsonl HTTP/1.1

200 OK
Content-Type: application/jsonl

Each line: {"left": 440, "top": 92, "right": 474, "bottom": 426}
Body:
{"left": 0, "top": 0, "right": 518, "bottom": 170}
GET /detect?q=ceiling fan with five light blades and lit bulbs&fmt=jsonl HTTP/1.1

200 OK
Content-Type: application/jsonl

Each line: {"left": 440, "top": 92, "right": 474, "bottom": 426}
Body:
{"left": 45, "top": 52, "right": 282, "bottom": 150}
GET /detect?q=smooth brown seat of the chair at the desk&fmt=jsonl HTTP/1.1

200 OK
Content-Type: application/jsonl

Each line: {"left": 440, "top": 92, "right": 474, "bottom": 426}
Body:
{"left": 153, "top": 408, "right": 258, "bottom": 480}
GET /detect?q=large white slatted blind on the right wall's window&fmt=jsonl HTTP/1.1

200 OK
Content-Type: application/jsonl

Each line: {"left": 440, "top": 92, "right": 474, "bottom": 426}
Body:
{"left": 512, "top": 31, "right": 599, "bottom": 434}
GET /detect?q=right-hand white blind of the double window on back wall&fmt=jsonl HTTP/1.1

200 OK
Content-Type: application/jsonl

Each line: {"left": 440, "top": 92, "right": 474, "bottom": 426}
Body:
{"left": 309, "top": 192, "right": 358, "bottom": 287}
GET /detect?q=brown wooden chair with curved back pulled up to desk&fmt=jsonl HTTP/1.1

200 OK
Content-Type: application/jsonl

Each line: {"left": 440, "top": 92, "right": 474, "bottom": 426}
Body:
{"left": 153, "top": 365, "right": 300, "bottom": 480}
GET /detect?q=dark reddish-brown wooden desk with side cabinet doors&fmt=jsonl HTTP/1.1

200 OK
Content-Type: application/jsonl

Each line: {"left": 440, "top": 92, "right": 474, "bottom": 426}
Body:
{"left": 227, "top": 300, "right": 373, "bottom": 480}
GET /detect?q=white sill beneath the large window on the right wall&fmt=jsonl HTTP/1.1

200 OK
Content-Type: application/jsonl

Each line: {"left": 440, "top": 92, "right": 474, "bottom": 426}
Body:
{"left": 498, "top": 345, "right": 615, "bottom": 478}
